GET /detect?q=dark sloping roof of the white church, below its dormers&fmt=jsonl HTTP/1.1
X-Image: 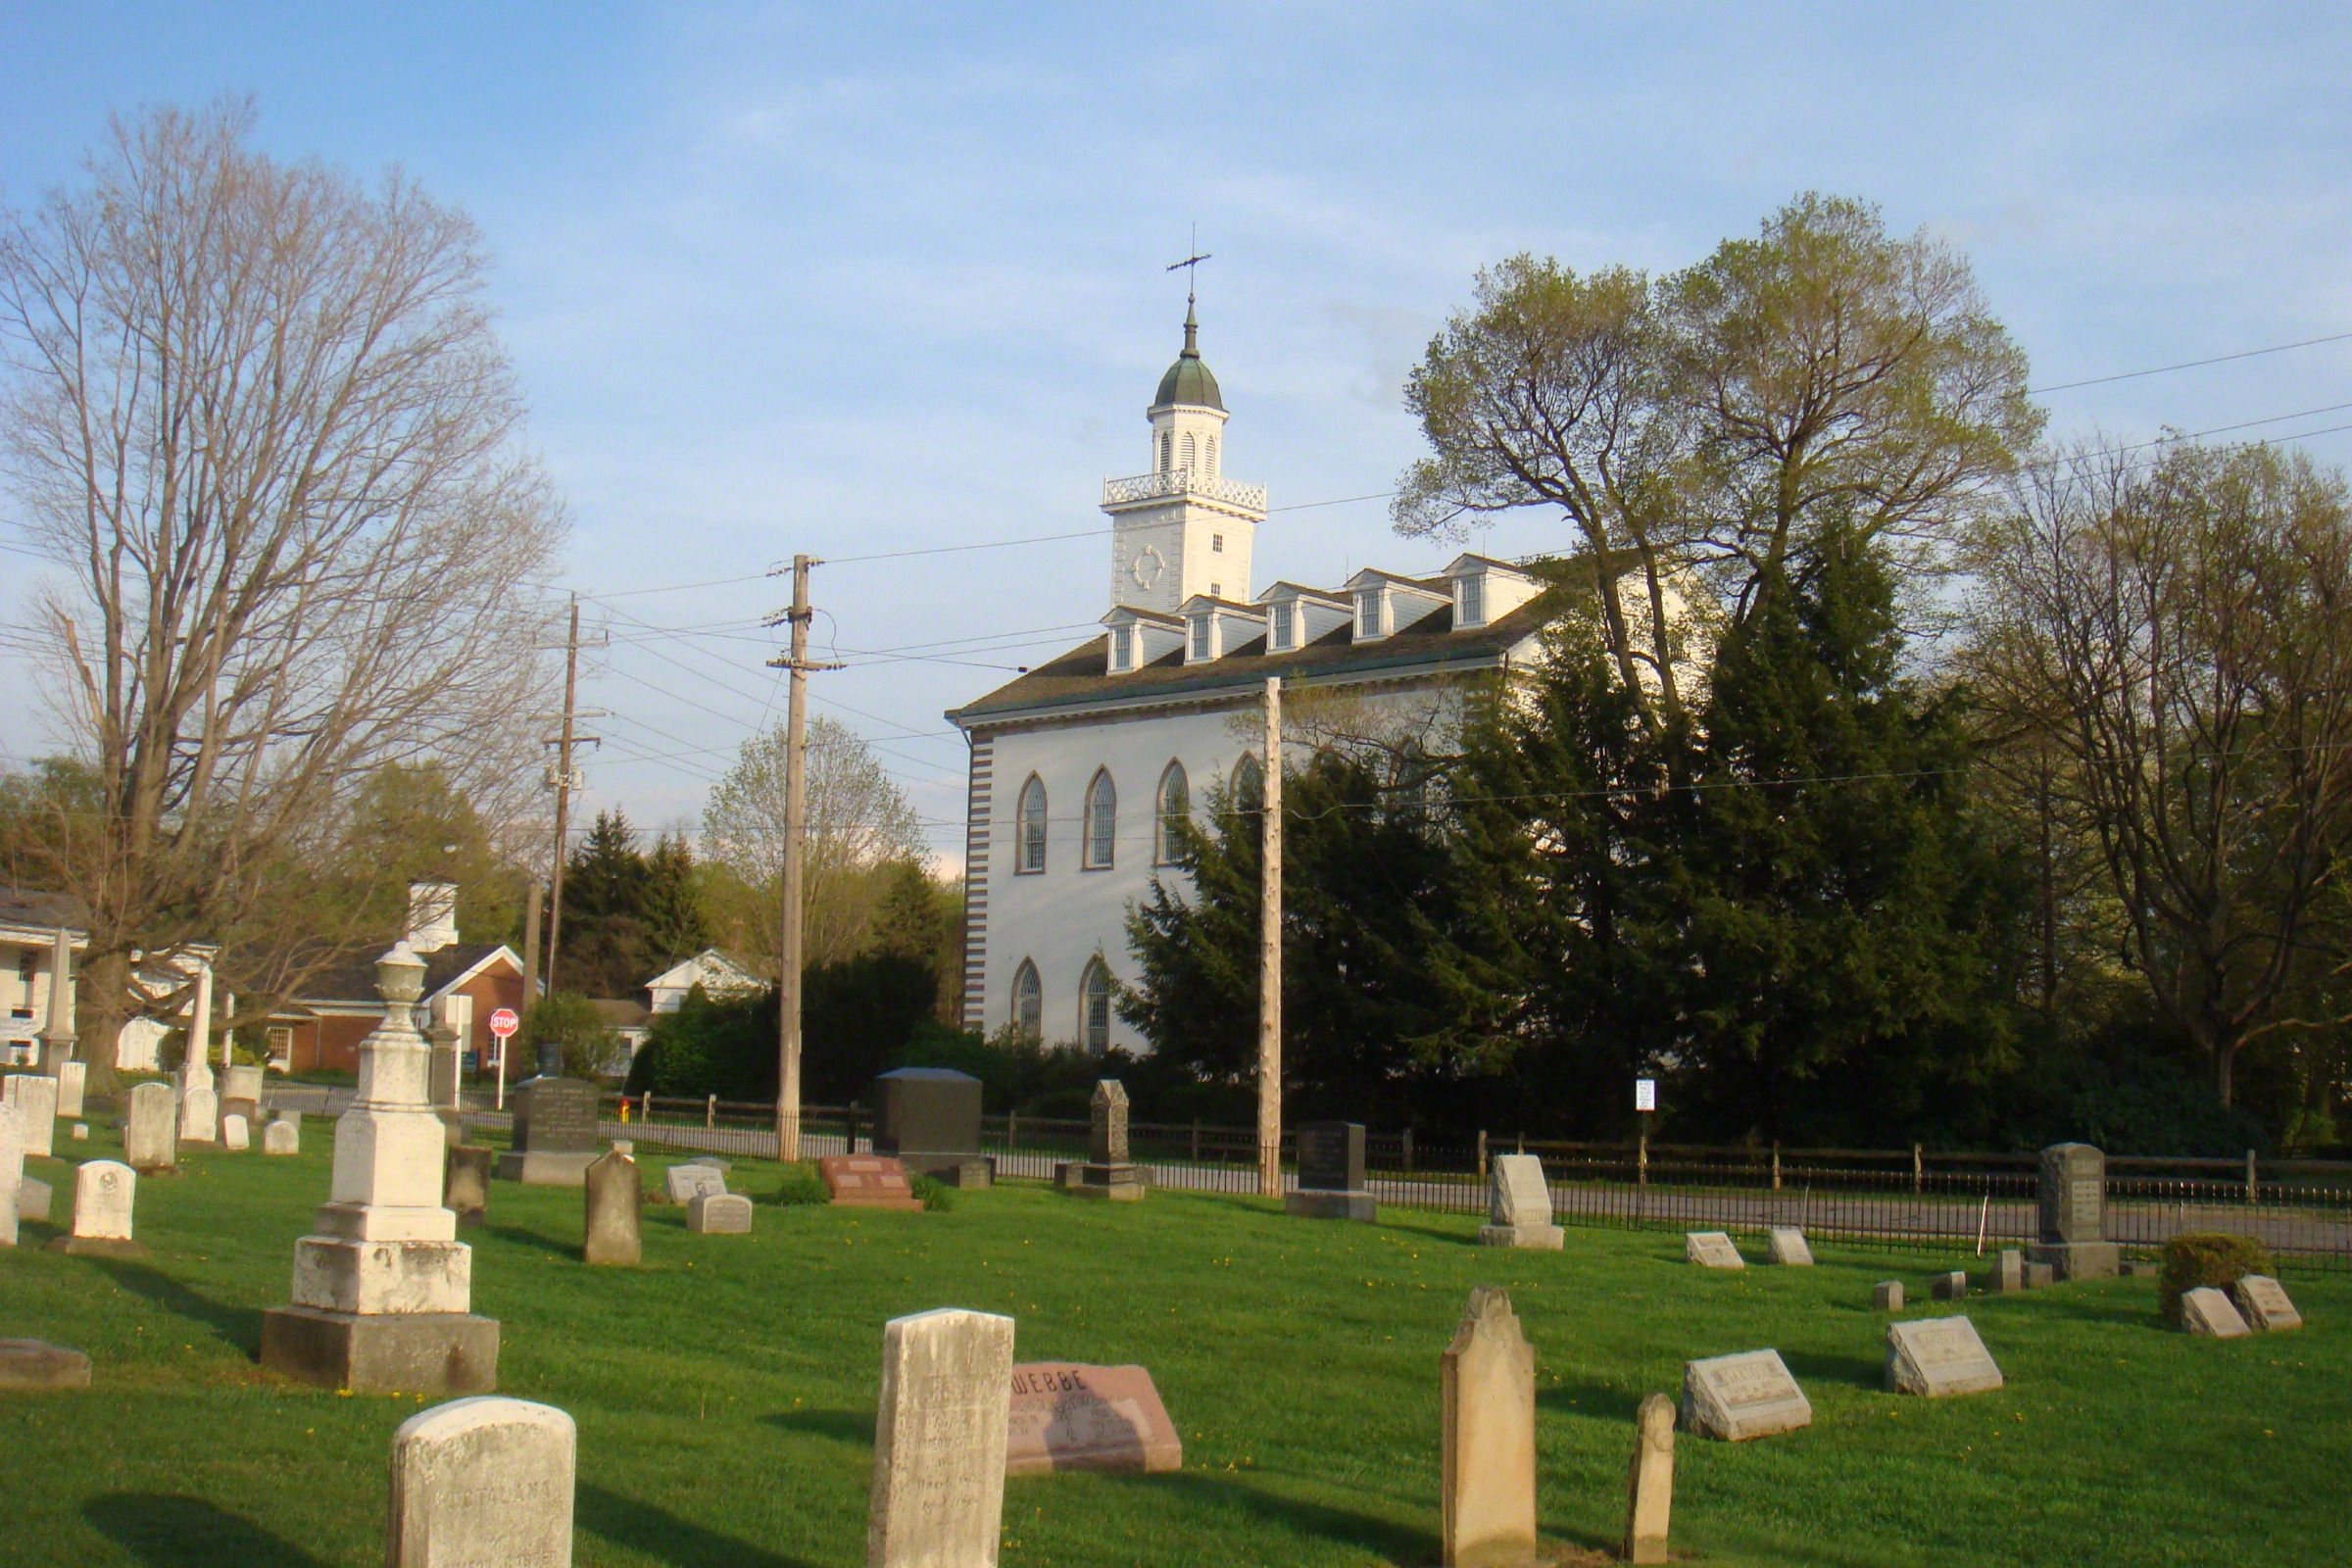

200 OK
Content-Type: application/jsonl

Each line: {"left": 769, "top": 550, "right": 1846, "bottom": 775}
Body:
{"left": 948, "top": 595, "right": 1552, "bottom": 729}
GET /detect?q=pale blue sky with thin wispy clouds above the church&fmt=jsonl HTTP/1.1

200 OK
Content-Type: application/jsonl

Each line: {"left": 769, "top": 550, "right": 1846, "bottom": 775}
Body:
{"left": 0, "top": 0, "right": 2352, "bottom": 858}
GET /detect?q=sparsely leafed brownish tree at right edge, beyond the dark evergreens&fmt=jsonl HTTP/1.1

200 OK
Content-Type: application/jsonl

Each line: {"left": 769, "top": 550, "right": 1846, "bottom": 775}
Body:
{"left": 1971, "top": 447, "right": 2352, "bottom": 1102}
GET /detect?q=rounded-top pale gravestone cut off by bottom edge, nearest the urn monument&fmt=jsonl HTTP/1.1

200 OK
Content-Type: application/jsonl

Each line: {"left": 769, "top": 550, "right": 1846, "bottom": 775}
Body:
{"left": 383, "top": 1400, "right": 578, "bottom": 1568}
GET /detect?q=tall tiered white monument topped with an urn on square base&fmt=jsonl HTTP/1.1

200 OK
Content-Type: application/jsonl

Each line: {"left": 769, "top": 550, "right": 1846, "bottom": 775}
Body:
{"left": 261, "top": 943, "right": 499, "bottom": 1394}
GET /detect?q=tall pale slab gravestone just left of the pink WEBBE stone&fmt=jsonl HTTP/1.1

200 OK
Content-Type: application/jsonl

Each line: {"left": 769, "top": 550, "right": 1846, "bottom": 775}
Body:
{"left": 865, "top": 1307, "right": 1013, "bottom": 1568}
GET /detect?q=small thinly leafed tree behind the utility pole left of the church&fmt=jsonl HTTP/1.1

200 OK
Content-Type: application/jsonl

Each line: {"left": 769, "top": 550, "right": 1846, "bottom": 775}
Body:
{"left": 704, "top": 714, "right": 924, "bottom": 982}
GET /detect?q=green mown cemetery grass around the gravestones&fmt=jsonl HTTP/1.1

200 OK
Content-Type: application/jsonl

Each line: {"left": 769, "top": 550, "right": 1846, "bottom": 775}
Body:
{"left": 0, "top": 1119, "right": 2352, "bottom": 1568}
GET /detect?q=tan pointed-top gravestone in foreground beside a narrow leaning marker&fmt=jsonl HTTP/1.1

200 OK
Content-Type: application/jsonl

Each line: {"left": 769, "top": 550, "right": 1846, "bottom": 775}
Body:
{"left": 1440, "top": 1286, "right": 1536, "bottom": 1568}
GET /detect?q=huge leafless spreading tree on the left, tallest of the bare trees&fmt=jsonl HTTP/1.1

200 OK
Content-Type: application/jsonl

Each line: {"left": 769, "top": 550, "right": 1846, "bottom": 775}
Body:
{"left": 0, "top": 101, "right": 563, "bottom": 1084}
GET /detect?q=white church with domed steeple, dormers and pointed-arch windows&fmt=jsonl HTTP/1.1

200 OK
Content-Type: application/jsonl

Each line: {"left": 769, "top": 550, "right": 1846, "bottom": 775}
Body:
{"left": 948, "top": 311, "right": 1543, "bottom": 1049}
